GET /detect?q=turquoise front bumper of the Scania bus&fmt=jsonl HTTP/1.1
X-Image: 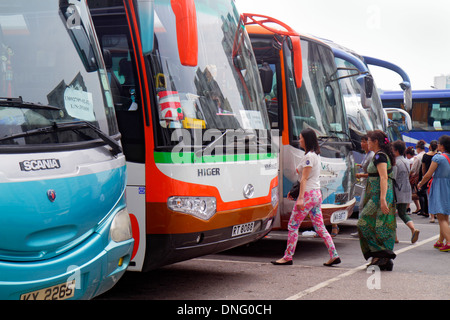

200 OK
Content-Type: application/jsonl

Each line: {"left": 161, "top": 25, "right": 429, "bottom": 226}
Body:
{"left": 0, "top": 212, "right": 134, "bottom": 300}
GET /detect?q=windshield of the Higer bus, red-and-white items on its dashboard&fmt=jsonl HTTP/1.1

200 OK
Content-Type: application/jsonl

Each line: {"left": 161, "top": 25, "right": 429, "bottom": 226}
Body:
{"left": 140, "top": 0, "right": 269, "bottom": 136}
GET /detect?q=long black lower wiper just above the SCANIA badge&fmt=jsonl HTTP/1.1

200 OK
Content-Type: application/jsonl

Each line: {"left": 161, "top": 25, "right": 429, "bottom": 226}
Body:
{"left": 0, "top": 121, "right": 123, "bottom": 156}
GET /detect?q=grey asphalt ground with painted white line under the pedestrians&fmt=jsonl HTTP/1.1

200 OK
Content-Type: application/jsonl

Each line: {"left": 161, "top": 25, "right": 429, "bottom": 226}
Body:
{"left": 97, "top": 205, "right": 450, "bottom": 301}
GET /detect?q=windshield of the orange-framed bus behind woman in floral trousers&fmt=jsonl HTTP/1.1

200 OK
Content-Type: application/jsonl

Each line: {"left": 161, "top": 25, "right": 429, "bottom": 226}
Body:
{"left": 284, "top": 39, "right": 349, "bottom": 141}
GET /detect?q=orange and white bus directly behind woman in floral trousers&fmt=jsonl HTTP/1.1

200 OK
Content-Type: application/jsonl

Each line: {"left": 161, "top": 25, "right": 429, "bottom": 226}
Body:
{"left": 243, "top": 13, "right": 356, "bottom": 229}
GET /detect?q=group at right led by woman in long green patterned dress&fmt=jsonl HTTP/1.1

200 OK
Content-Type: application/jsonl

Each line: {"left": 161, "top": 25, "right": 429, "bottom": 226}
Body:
{"left": 357, "top": 130, "right": 450, "bottom": 270}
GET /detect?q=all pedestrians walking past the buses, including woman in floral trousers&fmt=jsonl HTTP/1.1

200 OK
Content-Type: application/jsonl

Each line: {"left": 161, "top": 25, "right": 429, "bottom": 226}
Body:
{"left": 272, "top": 129, "right": 450, "bottom": 271}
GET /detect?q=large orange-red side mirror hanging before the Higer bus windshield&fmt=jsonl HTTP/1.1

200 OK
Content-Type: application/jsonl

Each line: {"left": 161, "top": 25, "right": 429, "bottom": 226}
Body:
{"left": 170, "top": 0, "right": 198, "bottom": 67}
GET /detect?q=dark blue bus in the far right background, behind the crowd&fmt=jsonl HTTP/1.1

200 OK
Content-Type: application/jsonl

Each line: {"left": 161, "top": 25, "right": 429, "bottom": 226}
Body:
{"left": 381, "top": 90, "right": 450, "bottom": 147}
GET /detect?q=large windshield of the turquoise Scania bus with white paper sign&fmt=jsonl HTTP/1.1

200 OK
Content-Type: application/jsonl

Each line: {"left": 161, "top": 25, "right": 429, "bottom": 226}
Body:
{"left": 0, "top": 0, "right": 118, "bottom": 149}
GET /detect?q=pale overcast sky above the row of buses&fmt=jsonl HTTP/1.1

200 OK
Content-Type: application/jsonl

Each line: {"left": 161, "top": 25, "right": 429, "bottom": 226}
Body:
{"left": 235, "top": 0, "right": 450, "bottom": 90}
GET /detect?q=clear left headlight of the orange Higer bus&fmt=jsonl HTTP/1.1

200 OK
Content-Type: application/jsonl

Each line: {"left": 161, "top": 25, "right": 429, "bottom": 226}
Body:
{"left": 167, "top": 197, "right": 216, "bottom": 220}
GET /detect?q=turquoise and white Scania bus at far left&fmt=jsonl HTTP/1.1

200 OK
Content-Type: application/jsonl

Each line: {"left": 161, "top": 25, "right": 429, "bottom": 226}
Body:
{"left": 0, "top": 0, "right": 134, "bottom": 300}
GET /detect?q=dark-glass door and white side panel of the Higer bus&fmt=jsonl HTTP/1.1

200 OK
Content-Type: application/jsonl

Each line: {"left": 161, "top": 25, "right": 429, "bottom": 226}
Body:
{"left": 86, "top": 5, "right": 146, "bottom": 270}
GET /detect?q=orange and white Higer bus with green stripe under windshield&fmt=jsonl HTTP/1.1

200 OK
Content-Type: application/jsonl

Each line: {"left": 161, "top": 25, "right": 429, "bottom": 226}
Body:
{"left": 88, "top": 0, "right": 278, "bottom": 271}
